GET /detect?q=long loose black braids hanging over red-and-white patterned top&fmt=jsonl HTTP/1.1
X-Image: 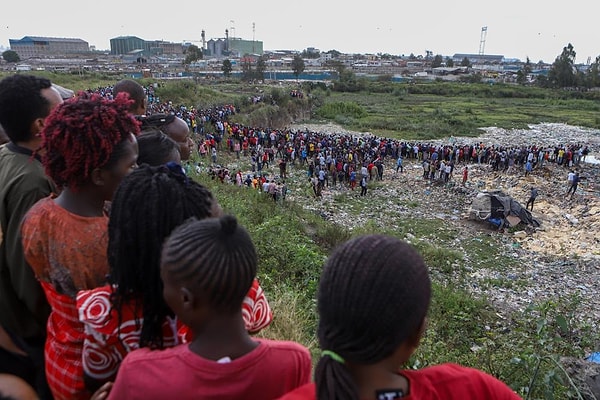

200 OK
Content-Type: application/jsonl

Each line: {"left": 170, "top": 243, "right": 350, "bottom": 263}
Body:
{"left": 108, "top": 165, "right": 215, "bottom": 348}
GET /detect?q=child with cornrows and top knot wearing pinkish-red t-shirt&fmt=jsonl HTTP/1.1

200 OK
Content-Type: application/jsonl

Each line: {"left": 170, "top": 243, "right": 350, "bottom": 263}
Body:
{"left": 109, "top": 215, "right": 311, "bottom": 400}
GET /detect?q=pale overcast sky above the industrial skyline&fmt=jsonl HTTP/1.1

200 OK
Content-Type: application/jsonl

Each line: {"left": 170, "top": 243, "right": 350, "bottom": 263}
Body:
{"left": 0, "top": 0, "right": 600, "bottom": 63}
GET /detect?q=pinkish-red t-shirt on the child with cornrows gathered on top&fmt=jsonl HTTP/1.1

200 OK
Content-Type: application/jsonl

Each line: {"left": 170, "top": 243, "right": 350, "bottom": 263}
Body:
{"left": 109, "top": 339, "right": 311, "bottom": 400}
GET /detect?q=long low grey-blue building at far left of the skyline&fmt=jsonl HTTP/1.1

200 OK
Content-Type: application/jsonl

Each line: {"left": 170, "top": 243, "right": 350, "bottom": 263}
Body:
{"left": 9, "top": 36, "right": 90, "bottom": 59}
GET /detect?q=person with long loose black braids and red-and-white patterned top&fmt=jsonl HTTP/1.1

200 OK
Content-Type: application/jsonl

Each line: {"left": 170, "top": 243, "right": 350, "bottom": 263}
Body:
{"left": 77, "top": 164, "right": 273, "bottom": 396}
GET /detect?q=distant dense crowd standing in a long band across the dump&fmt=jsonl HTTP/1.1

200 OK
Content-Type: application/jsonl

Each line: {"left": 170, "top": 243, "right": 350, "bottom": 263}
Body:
{"left": 186, "top": 118, "right": 590, "bottom": 203}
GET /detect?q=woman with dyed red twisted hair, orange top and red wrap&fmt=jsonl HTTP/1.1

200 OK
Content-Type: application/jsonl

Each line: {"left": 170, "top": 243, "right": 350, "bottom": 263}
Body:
{"left": 22, "top": 94, "right": 139, "bottom": 400}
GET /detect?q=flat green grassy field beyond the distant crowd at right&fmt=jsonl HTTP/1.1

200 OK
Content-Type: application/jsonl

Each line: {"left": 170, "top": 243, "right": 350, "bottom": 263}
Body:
{"left": 310, "top": 83, "right": 600, "bottom": 140}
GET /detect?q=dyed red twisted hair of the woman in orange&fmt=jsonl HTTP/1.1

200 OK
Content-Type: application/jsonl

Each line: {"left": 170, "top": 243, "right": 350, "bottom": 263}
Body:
{"left": 42, "top": 92, "right": 140, "bottom": 190}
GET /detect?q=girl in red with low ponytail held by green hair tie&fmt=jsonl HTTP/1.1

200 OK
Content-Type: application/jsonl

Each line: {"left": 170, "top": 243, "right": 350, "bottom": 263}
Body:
{"left": 281, "top": 235, "right": 520, "bottom": 400}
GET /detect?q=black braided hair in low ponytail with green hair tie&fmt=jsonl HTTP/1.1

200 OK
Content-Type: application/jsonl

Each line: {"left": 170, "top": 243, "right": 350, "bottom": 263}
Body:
{"left": 315, "top": 235, "right": 431, "bottom": 400}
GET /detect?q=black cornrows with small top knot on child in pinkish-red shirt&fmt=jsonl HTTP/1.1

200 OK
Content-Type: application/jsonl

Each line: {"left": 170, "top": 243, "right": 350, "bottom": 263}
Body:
{"left": 161, "top": 215, "right": 258, "bottom": 314}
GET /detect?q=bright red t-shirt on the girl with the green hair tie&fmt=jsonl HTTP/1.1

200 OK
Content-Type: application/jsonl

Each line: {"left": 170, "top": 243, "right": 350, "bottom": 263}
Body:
{"left": 280, "top": 364, "right": 521, "bottom": 400}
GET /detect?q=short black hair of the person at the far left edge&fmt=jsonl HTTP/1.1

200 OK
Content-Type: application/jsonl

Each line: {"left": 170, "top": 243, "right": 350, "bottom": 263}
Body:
{"left": 0, "top": 74, "right": 52, "bottom": 142}
